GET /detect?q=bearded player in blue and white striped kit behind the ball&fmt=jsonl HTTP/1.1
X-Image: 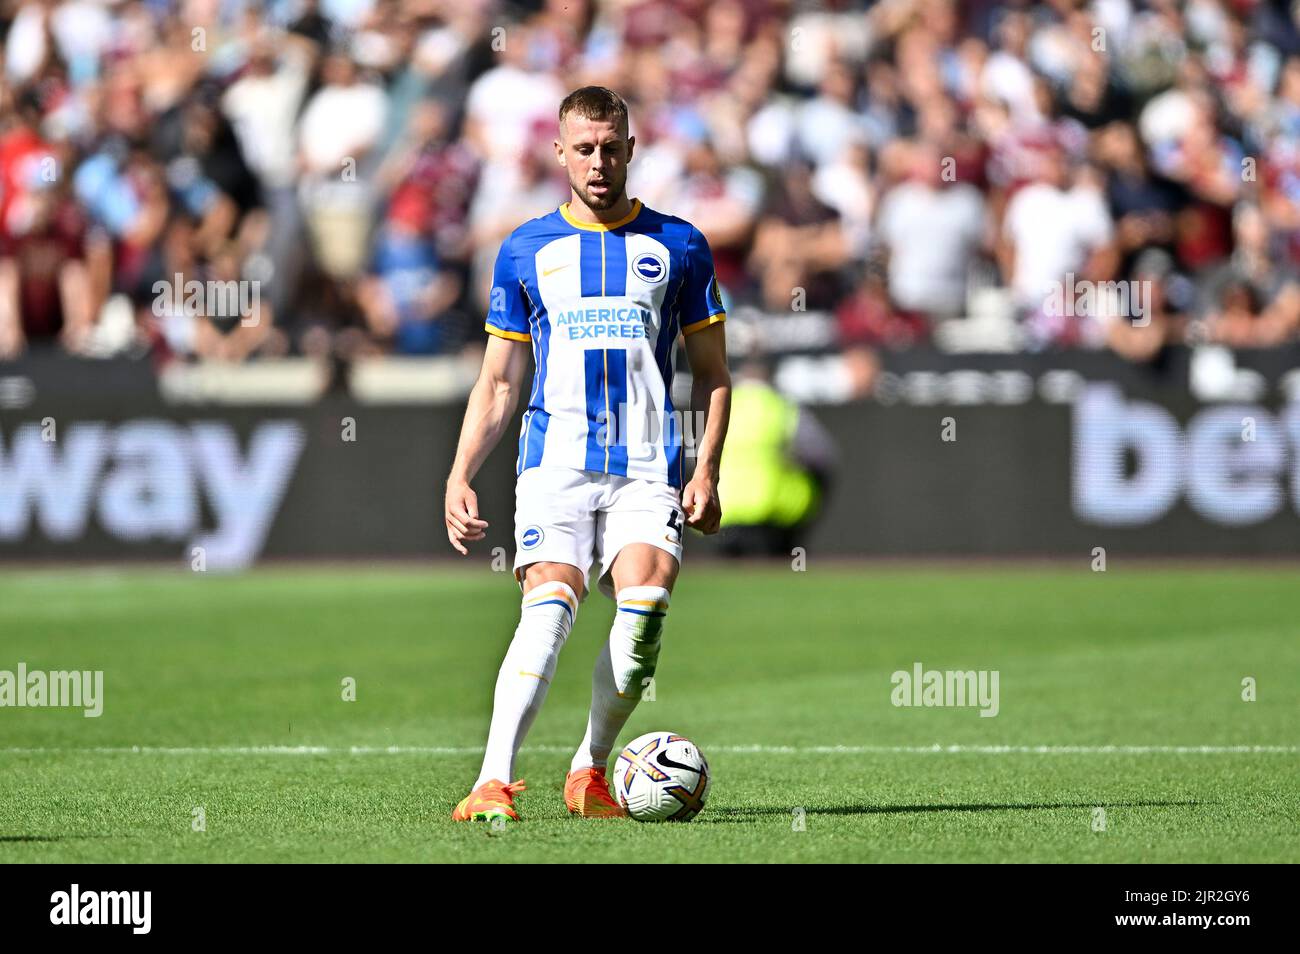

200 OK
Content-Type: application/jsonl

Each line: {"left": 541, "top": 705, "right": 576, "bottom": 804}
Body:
{"left": 446, "top": 86, "right": 731, "bottom": 821}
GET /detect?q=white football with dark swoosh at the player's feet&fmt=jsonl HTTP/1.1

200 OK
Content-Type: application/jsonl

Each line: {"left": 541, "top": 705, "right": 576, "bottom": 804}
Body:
{"left": 614, "top": 732, "right": 711, "bottom": 821}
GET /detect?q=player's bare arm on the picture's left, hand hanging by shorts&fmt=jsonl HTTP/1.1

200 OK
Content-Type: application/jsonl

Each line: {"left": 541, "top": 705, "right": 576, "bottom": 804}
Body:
{"left": 445, "top": 335, "right": 532, "bottom": 555}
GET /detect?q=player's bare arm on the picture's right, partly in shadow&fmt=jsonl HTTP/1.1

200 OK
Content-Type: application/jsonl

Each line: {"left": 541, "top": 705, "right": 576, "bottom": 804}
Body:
{"left": 681, "top": 321, "right": 731, "bottom": 533}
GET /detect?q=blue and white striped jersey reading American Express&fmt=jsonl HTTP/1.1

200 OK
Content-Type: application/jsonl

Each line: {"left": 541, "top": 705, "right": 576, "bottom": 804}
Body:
{"left": 486, "top": 200, "right": 727, "bottom": 487}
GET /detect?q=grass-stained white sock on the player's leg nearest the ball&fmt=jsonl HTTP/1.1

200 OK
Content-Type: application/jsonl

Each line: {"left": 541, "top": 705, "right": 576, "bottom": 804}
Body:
{"left": 569, "top": 586, "right": 668, "bottom": 772}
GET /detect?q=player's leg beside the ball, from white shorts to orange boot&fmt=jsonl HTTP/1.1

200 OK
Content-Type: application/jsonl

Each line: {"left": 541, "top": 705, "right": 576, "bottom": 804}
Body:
{"left": 566, "top": 481, "right": 681, "bottom": 815}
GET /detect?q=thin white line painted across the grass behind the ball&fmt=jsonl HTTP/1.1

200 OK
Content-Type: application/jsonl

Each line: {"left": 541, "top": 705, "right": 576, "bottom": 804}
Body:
{"left": 0, "top": 745, "right": 1300, "bottom": 755}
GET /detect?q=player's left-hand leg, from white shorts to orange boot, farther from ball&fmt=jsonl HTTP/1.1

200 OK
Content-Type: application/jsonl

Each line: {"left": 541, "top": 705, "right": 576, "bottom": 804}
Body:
{"left": 452, "top": 469, "right": 595, "bottom": 820}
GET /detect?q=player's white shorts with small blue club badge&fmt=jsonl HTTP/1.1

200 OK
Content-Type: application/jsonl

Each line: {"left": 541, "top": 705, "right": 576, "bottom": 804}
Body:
{"left": 515, "top": 467, "right": 685, "bottom": 599}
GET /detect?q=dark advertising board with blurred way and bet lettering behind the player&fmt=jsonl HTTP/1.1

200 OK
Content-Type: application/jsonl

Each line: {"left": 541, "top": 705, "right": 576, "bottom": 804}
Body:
{"left": 0, "top": 372, "right": 1300, "bottom": 569}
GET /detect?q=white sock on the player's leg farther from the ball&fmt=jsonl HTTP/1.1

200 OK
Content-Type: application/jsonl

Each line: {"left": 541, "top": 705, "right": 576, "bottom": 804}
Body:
{"left": 475, "top": 581, "right": 577, "bottom": 788}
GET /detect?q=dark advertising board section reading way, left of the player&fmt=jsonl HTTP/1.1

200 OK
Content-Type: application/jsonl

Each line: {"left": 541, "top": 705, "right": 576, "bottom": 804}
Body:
{"left": 0, "top": 399, "right": 514, "bottom": 569}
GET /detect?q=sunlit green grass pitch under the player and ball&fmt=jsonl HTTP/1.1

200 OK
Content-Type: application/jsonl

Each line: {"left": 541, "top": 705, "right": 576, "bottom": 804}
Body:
{"left": 0, "top": 560, "right": 1300, "bottom": 862}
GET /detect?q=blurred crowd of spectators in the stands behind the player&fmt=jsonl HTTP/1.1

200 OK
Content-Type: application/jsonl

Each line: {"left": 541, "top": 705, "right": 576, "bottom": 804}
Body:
{"left": 0, "top": 0, "right": 1300, "bottom": 377}
